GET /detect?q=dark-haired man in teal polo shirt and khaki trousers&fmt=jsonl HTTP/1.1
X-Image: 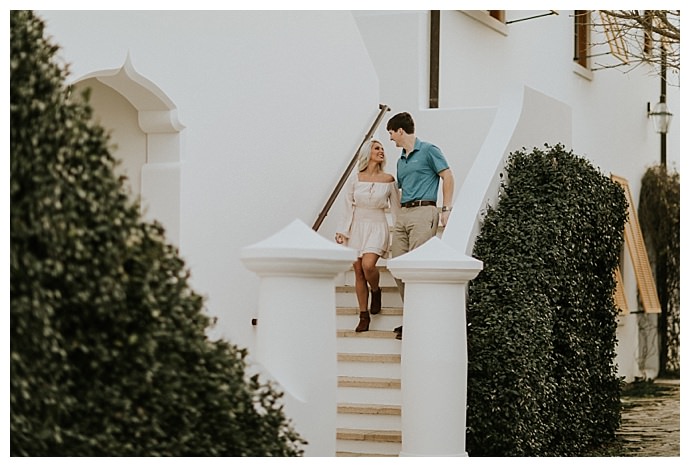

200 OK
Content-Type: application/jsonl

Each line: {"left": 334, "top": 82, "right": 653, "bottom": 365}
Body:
{"left": 386, "top": 112, "right": 455, "bottom": 339}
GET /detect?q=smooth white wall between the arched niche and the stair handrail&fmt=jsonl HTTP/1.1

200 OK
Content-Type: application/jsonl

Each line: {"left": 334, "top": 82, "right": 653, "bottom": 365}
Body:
{"left": 38, "top": 11, "right": 379, "bottom": 350}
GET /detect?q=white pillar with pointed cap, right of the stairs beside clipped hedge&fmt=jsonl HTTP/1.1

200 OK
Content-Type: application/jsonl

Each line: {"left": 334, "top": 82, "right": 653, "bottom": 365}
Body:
{"left": 388, "top": 237, "right": 483, "bottom": 456}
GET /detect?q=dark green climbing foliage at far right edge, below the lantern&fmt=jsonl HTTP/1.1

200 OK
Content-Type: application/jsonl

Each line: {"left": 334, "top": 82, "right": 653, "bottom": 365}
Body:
{"left": 638, "top": 165, "right": 680, "bottom": 376}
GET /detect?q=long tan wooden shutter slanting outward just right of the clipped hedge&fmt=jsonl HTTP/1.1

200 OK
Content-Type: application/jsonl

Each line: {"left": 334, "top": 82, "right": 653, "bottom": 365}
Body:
{"left": 611, "top": 175, "right": 661, "bottom": 313}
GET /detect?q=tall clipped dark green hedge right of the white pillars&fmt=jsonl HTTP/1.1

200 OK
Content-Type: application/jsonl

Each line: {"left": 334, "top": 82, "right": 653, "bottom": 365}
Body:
{"left": 467, "top": 145, "right": 627, "bottom": 456}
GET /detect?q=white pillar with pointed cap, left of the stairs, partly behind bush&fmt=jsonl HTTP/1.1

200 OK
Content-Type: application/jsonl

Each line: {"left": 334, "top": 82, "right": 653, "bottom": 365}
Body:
{"left": 240, "top": 220, "right": 357, "bottom": 457}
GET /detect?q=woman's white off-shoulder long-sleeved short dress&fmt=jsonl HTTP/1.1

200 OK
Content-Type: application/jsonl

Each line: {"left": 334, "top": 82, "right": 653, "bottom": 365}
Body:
{"left": 337, "top": 175, "right": 400, "bottom": 257}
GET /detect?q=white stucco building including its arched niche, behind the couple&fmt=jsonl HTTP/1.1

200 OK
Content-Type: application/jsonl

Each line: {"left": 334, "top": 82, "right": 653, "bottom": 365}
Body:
{"left": 38, "top": 10, "right": 680, "bottom": 455}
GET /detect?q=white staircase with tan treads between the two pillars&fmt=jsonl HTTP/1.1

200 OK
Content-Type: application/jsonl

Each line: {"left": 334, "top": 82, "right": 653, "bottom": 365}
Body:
{"left": 336, "top": 258, "right": 402, "bottom": 457}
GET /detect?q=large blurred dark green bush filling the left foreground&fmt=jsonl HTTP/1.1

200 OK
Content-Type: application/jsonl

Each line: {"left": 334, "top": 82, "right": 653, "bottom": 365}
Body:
{"left": 10, "top": 11, "right": 302, "bottom": 456}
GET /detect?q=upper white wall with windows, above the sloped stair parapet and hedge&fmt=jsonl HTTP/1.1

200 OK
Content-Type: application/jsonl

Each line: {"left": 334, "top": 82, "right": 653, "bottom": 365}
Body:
{"left": 355, "top": 10, "right": 681, "bottom": 196}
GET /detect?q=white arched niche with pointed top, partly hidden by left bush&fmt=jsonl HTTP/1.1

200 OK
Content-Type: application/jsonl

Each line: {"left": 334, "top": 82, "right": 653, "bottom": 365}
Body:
{"left": 74, "top": 56, "right": 184, "bottom": 244}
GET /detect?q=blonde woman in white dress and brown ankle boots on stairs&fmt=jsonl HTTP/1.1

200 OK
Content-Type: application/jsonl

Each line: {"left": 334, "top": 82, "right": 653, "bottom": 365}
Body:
{"left": 335, "top": 140, "right": 400, "bottom": 332}
